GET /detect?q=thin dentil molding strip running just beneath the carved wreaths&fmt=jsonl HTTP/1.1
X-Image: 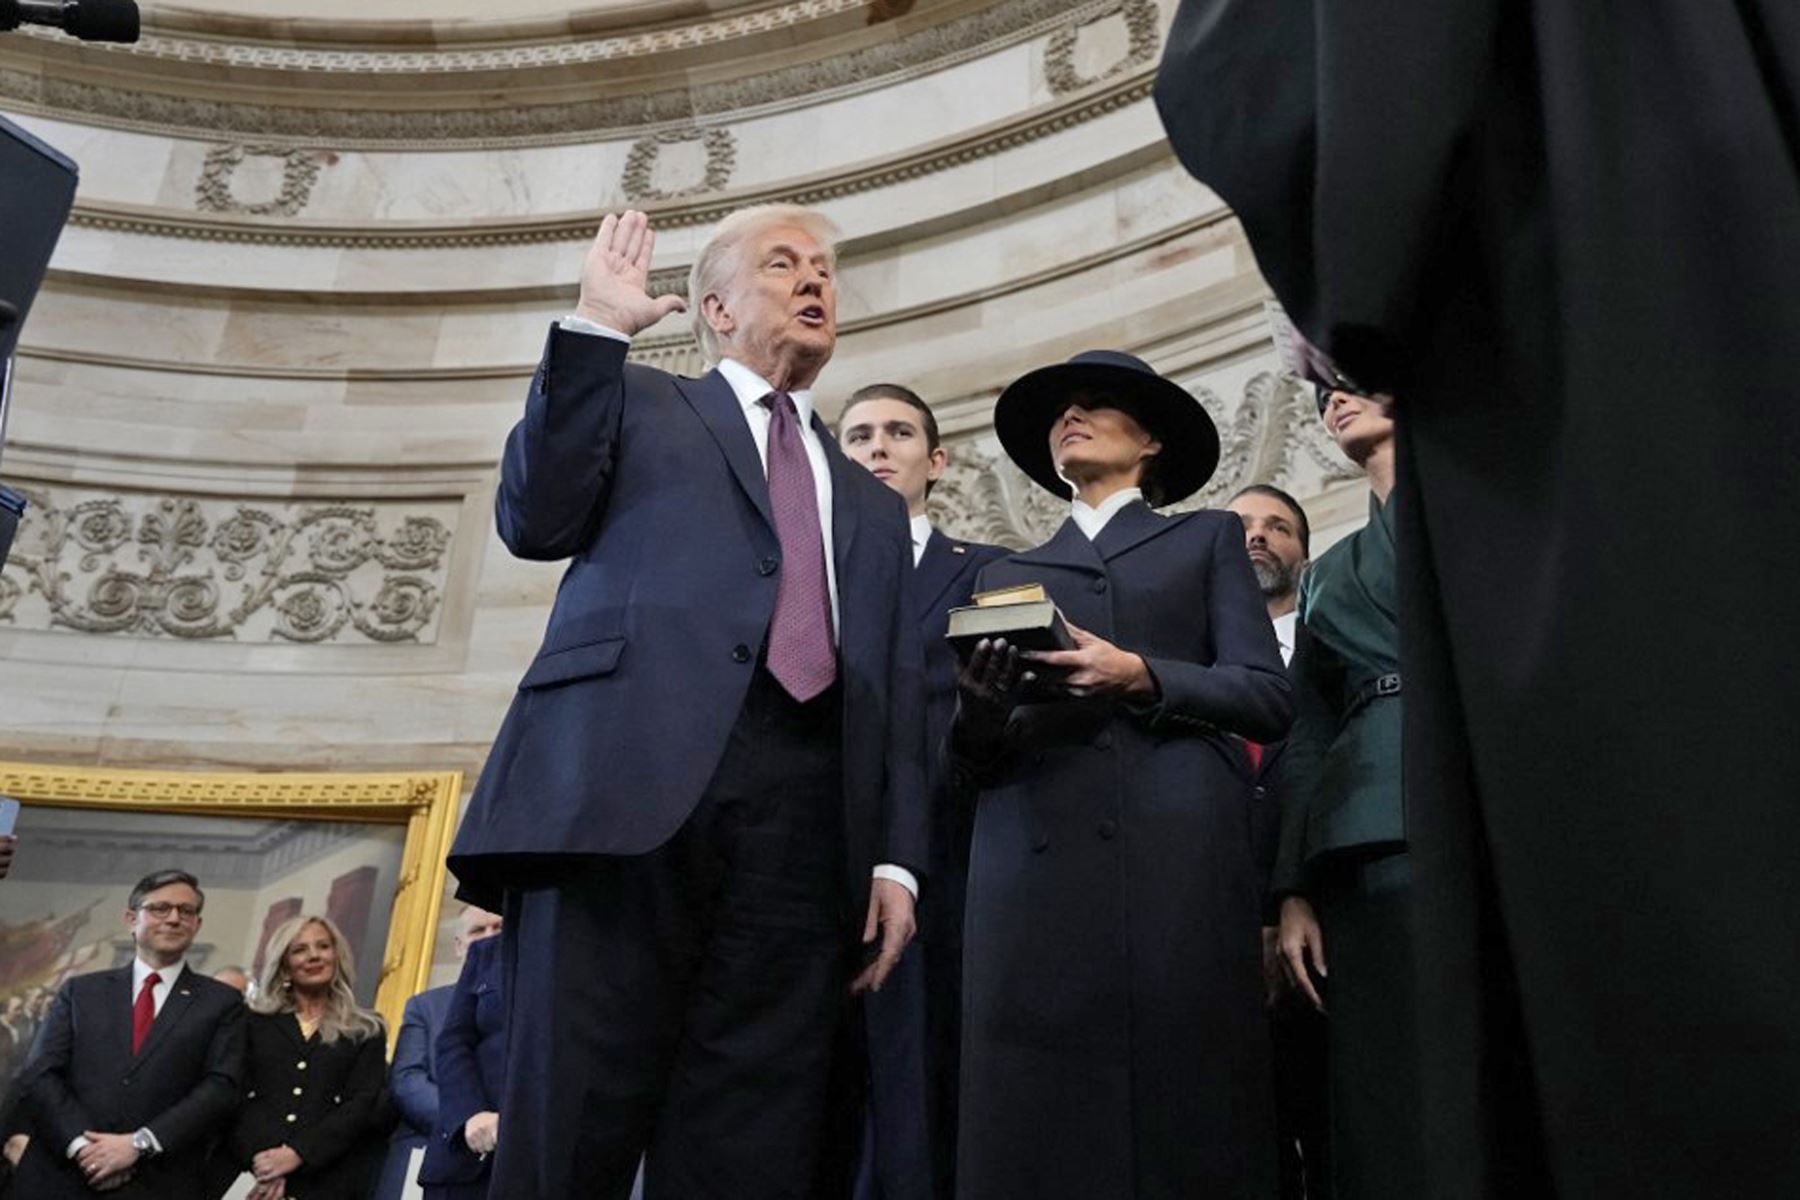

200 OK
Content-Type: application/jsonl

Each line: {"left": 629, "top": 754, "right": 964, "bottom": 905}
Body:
{"left": 63, "top": 72, "right": 1166, "bottom": 250}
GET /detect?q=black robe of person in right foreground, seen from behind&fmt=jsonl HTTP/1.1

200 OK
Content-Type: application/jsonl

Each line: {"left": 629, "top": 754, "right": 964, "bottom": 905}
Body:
{"left": 1157, "top": 0, "right": 1800, "bottom": 1196}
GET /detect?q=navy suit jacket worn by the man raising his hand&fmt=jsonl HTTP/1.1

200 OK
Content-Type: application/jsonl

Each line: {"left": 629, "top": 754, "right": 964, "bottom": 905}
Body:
{"left": 450, "top": 327, "right": 929, "bottom": 912}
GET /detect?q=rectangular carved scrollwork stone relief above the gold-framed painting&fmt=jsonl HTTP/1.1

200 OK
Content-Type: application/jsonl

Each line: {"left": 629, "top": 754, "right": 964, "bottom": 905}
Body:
{"left": 0, "top": 486, "right": 459, "bottom": 646}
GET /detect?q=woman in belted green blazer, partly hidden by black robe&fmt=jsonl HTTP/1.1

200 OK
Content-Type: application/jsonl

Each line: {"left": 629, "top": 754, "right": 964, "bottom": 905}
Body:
{"left": 1273, "top": 390, "right": 1424, "bottom": 1200}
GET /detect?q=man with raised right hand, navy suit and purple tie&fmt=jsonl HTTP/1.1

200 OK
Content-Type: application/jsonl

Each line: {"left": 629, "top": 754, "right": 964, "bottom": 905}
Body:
{"left": 450, "top": 205, "right": 929, "bottom": 1200}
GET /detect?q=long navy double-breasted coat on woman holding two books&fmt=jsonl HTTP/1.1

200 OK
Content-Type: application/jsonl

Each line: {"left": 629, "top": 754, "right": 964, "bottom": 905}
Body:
{"left": 958, "top": 504, "right": 1292, "bottom": 1200}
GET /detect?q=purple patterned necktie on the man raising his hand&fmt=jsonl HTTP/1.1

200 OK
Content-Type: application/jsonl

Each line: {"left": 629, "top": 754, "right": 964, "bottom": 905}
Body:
{"left": 761, "top": 392, "right": 837, "bottom": 702}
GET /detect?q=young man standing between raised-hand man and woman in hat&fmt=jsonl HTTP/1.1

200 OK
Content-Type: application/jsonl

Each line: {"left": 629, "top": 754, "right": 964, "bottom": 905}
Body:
{"left": 837, "top": 383, "right": 1006, "bottom": 1200}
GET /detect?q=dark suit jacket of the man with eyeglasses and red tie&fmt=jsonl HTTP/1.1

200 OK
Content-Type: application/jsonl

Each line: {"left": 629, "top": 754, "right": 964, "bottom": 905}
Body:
{"left": 13, "top": 964, "right": 245, "bottom": 1200}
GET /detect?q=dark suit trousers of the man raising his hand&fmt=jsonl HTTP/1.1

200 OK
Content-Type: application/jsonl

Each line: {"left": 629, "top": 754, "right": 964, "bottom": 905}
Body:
{"left": 488, "top": 669, "right": 860, "bottom": 1200}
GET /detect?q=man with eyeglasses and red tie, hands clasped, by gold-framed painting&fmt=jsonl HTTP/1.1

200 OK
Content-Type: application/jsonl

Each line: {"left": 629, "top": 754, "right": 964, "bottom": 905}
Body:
{"left": 16, "top": 871, "right": 245, "bottom": 1200}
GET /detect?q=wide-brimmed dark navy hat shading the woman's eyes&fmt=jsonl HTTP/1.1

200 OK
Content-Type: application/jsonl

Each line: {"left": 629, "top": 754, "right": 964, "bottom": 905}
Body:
{"left": 994, "top": 351, "right": 1219, "bottom": 504}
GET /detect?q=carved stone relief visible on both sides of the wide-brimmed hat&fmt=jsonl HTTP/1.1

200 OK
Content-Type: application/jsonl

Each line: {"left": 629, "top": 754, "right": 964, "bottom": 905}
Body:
{"left": 931, "top": 371, "right": 1361, "bottom": 549}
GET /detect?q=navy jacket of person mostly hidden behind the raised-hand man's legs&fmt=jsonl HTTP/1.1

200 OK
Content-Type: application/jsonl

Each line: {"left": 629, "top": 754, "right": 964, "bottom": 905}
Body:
{"left": 419, "top": 937, "right": 506, "bottom": 1186}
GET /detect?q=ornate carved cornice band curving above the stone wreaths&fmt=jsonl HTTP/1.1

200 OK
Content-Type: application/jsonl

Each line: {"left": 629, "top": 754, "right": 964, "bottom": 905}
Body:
{"left": 0, "top": 0, "right": 1116, "bottom": 151}
